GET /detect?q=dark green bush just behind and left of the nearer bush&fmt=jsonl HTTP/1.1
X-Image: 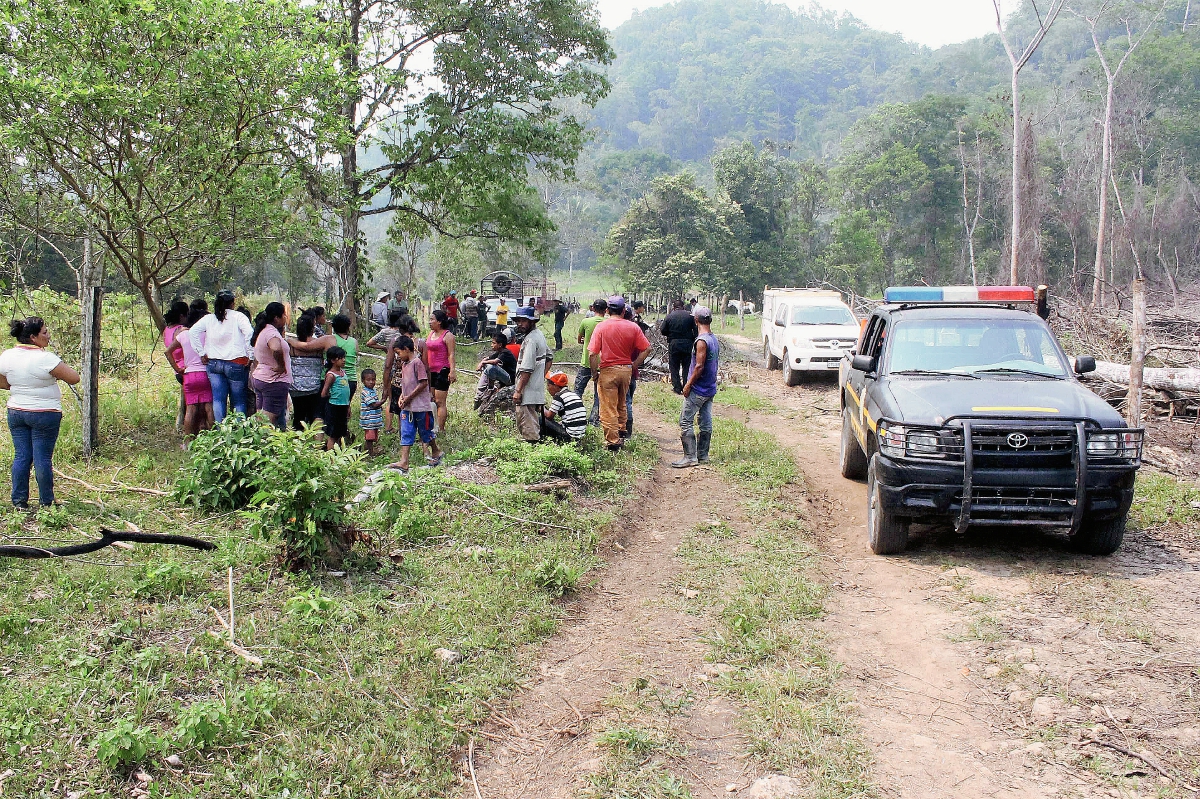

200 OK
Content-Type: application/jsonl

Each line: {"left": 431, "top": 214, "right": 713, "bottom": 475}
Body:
{"left": 175, "top": 414, "right": 283, "bottom": 511}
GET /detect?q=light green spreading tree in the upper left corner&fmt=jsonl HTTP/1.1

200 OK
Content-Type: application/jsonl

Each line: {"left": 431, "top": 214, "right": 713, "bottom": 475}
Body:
{"left": 0, "top": 0, "right": 320, "bottom": 328}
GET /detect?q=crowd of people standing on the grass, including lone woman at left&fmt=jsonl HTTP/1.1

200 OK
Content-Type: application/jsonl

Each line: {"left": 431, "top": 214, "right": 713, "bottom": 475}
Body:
{"left": 0, "top": 290, "right": 720, "bottom": 507}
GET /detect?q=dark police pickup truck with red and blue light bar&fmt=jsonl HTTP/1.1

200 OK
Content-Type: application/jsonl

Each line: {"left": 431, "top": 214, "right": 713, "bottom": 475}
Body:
{"left": 839, "top": 287, "right": 1142, "bottom": 554}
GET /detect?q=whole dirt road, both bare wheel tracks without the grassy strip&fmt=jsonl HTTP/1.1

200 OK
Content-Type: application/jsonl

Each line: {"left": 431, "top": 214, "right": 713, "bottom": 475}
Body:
{"left": 463, "top": 359, "right": 1200, "bottom": 799}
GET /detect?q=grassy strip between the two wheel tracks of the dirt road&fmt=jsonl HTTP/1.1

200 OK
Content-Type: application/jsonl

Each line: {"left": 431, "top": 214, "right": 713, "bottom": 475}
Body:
{"left": 643, "top": 386, "right": 875, "bottom": 798}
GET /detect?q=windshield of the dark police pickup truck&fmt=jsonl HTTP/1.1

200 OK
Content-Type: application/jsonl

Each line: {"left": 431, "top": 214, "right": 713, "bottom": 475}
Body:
{"left": 888, "top": 319, "right": 1067, "bottom": 378}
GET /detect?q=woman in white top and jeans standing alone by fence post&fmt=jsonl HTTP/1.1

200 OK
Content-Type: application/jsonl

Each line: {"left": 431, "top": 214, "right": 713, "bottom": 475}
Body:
{"left": 0, "top": 317, "right": 79, "bottom": 507}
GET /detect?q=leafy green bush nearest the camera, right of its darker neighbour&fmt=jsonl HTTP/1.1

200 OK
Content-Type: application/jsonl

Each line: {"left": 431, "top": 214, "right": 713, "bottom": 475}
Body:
{"left": 238, "top": 429, "right": 364, "bottom": 567}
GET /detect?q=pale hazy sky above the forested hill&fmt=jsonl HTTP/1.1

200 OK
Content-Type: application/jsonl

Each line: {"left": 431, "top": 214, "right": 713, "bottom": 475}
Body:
{"left": 598, "top": 0, "right": 998, "bottom": 47}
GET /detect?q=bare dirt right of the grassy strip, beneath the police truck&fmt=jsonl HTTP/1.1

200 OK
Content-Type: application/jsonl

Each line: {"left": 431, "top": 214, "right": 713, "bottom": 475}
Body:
{"left": 727, "top": 371, "right": 1200, "bottom": 797}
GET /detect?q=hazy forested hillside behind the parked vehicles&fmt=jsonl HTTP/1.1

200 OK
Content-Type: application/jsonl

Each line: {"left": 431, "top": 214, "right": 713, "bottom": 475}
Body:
{"left": 556, "top": 0, "right": 1200, "bottom": 302}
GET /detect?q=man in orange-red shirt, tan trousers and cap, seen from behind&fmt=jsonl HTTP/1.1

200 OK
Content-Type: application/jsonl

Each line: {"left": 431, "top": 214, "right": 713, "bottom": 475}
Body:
{"left": 588, "top": 296, "right": 650, "bottom": 452}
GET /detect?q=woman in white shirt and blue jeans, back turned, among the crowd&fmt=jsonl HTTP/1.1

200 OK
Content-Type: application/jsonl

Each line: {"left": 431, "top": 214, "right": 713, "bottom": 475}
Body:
{"left": 187, "top": 290, "right": 254, "bottom": 423}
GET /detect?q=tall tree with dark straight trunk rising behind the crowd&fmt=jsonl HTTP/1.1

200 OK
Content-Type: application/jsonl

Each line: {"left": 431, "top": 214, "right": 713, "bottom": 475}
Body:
{"left": 304, "top": 0, "right": 611, "bottom": 314}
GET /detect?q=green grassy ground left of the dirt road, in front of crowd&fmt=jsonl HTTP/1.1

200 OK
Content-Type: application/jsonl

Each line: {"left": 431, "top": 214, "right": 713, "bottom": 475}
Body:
{"left": 0, "top": 328, "right": 657, "bottom": 798}
